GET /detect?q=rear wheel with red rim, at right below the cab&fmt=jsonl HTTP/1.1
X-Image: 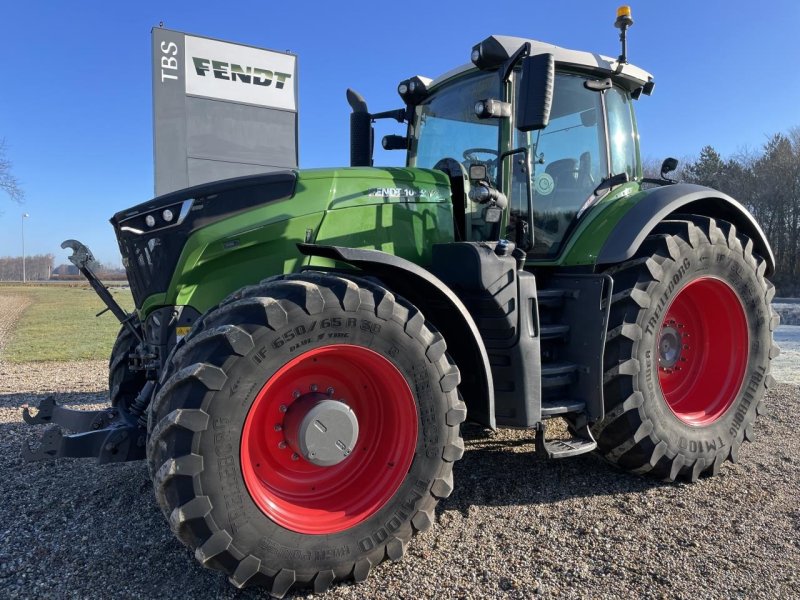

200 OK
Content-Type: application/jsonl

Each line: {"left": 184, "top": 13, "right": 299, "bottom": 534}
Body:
{"left": 593, "top": 215, "right": 778, "bottom": 480}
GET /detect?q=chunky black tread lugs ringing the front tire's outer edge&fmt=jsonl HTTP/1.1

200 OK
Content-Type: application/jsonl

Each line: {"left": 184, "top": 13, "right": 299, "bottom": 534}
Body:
{"left": 148, "top": 272, "right": 467, "bottom": 597}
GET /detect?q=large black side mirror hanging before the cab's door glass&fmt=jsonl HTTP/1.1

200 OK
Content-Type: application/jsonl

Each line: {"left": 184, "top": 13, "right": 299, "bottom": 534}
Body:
{"left": 516, "top": 54, "right": 555, "bottom": 131}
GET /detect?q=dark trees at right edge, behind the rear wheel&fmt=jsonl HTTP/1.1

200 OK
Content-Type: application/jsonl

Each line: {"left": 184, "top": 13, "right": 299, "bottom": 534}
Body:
{"left": 646, "top": 127, "right": 800, "bottom": 296}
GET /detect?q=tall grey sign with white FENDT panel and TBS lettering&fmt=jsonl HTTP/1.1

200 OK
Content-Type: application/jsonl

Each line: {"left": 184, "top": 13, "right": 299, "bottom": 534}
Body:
{"left": 152, "top": 27, "right": 298, "bottom": 195}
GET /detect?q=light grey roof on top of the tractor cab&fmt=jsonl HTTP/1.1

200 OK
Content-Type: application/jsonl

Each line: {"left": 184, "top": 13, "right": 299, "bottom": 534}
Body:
{"left": 429, "top": 35, "right": 653, "bottom": 91}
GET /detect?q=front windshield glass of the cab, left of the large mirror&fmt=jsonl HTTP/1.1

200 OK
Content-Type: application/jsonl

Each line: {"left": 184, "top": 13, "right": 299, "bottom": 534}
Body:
{"left": 411, "top": 73, "right": 500, "bottom": 176}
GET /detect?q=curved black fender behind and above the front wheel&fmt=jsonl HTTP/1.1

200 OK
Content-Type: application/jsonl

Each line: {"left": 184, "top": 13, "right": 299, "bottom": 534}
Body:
{"left": 297, "top": 244, "right": 496, "bottom": 429}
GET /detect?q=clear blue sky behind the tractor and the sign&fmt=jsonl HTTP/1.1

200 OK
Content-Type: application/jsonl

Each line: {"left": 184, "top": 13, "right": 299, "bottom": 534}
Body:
{"left": 0, "top": 0, "right": 800, "bottom": 264}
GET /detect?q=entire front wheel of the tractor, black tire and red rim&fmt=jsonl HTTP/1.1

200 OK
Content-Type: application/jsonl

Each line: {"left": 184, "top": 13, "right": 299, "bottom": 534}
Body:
{"left": 147, "top": 272, "right": 466, "bottom": 597}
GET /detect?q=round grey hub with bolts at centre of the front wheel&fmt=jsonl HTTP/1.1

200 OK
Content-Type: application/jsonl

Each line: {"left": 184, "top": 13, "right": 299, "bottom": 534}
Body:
{"left": 283, "top": 392, "right": 358, "bottom": 467}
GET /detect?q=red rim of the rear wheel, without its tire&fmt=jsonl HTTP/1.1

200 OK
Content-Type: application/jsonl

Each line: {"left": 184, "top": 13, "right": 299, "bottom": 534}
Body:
{"left": 656, "top": 277, "right": 749, "bottom": 426}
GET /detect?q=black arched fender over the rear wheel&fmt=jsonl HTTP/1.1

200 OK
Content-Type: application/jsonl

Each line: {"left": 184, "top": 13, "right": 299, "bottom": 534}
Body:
{"left": 597, "top": 183, "right": 775, "bottom": 276}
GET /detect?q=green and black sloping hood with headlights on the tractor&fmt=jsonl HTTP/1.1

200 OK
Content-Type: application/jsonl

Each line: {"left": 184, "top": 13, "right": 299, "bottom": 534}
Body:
{"left": 111, "top": 167, "right": 450, "bottom": 307}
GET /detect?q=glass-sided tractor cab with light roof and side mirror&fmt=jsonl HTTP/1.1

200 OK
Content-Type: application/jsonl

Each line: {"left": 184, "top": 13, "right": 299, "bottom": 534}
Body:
{"left": 399, "top": 36, "right": 653, "bottom": 259}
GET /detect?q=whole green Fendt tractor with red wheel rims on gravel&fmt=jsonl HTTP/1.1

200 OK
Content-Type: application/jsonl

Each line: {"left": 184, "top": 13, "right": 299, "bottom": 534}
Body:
{"left": 24, "top": 9, "right": 778, "bottom": 596}
